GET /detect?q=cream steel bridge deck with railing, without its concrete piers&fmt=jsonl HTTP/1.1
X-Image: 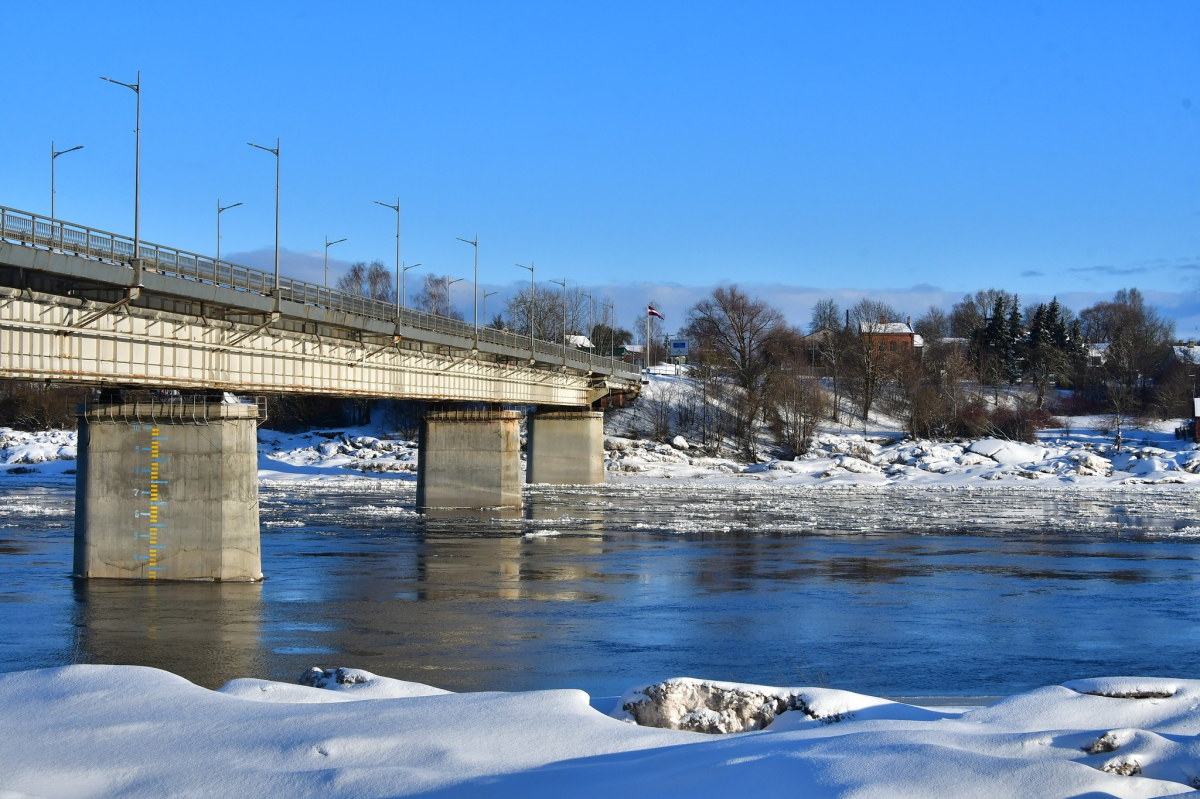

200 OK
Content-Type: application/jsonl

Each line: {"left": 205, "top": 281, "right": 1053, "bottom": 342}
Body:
{"left": 0, "top": 206, "right": 640, "bottom": 407}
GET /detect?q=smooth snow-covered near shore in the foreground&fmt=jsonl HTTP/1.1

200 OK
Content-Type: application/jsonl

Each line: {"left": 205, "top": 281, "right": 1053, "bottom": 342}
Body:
{"left": 0, "top": 666, "right": 1200, "bottom": 798}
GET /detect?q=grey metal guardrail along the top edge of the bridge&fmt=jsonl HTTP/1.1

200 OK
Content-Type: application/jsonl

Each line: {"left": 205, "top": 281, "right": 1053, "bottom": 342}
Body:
{"left": 0, "top": 205, "right": 640, "bottom": 379}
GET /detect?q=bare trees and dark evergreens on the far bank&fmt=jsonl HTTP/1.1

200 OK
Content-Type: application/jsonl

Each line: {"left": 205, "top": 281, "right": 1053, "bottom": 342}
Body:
{"left": 650, "top": 286, "right": 1195, "bottom": 456}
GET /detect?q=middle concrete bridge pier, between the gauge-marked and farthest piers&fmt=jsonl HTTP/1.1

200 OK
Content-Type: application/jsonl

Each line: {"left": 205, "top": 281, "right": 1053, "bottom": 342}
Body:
{"left": 416, "top": 410, "right": 521, "bottom": 510}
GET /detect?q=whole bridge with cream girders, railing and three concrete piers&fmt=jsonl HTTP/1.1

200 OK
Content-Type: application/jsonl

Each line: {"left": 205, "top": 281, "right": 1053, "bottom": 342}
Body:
{"left": 0, "top": 206, "right": 640, "bottom": 579}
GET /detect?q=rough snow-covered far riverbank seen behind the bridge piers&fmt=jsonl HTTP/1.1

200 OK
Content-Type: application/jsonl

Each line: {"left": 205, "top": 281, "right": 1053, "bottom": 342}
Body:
{"left": 0, "top": 417, "right": 1200, "bottom": 488}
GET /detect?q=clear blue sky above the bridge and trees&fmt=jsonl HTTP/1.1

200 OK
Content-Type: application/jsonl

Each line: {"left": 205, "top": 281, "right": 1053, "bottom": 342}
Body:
{"left": 0, "top": 2, "right": 1200, "bottom": 336}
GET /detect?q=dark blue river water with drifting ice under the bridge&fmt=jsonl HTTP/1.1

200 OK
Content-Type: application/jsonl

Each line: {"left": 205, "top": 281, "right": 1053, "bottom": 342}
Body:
{"left": 0, "top": 480, "right": 1200, "bottom": 697}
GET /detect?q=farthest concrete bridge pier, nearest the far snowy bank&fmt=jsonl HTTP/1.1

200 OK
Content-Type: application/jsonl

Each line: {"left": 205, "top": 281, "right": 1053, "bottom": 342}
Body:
{"left": 526, "top": 410, "right": 604, "bottom": 486}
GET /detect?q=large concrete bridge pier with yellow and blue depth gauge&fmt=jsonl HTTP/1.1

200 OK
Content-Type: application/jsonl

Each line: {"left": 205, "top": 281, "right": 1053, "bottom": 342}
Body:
{"left": 74, "top": 401, "right": 263, "bottom": 581}
